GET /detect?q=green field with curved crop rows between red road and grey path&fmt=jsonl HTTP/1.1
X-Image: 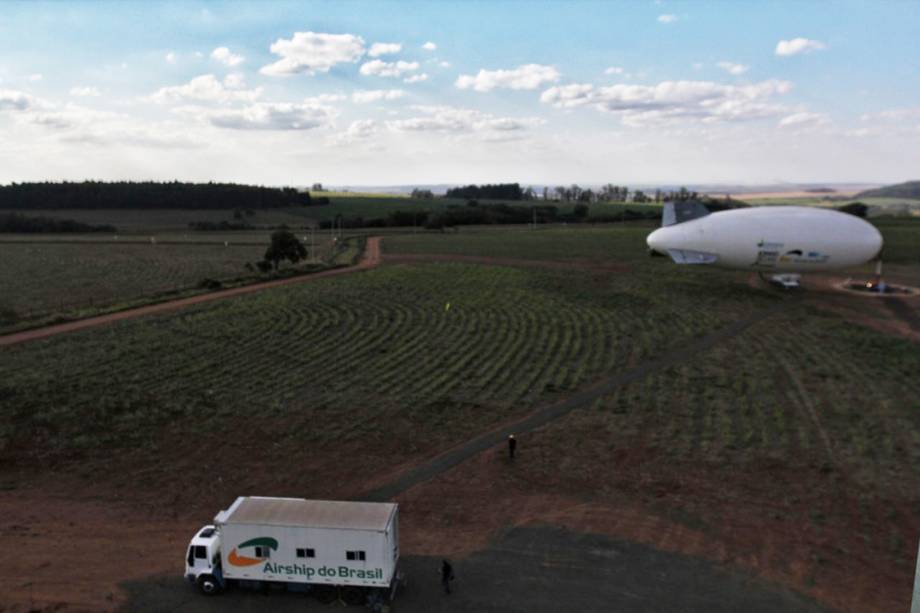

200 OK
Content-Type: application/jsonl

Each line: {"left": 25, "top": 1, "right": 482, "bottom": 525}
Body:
{"left": 0, "top": 256, "right": 765, "bottom": 453}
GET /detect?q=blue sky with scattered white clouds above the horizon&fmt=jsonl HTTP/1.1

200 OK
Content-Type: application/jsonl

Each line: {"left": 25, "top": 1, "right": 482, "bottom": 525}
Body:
{"left": 0, "top": 0, "right": 920, "bottom": 185}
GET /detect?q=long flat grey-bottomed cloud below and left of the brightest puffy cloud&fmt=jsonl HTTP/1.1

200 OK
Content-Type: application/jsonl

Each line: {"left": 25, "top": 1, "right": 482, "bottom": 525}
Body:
{"left": 176, "top": 102, "right": 336, "bottom": 130}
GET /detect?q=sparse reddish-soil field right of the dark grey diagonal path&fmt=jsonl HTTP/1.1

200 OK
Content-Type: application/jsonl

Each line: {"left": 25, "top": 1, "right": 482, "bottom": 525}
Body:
{"left": 510, "top": 306, "right": 920, "bottom": 610}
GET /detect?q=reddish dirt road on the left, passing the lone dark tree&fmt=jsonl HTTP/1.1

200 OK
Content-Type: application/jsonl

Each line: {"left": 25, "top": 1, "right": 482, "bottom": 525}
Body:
{"left": 0, "top": 236, "right": 380, "bottom": 347}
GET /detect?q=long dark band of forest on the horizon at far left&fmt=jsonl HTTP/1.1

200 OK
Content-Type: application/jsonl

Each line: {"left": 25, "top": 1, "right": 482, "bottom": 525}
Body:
{"left": 0, "top": 181, "right": 311, "bottom": 210}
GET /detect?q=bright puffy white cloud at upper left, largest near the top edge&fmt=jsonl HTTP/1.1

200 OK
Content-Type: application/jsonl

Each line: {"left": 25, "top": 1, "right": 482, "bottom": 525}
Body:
{"left": 260, "top": 32, "right": 364, "bottom": 76}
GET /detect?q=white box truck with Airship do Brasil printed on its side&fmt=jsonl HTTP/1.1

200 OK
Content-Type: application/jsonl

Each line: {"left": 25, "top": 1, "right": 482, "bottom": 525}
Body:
{"left": 185, "top": 496, "right": 400, "bottom": 609}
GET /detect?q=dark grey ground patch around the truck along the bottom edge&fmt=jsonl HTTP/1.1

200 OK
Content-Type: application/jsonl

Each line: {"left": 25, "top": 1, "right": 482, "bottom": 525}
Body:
{"left": 123, "top": 527, "right": 823, "bottom": 613}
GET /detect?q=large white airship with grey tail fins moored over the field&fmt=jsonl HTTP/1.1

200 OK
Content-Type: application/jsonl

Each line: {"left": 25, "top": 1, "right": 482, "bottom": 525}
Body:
{"left": 646, "top": 202, "right": 882, "bottom": 286}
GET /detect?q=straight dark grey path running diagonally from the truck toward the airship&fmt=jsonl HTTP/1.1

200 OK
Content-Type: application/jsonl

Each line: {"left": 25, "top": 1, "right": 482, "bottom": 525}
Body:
{"left": 362, "top": 304, "right": 786, "bottom": 500}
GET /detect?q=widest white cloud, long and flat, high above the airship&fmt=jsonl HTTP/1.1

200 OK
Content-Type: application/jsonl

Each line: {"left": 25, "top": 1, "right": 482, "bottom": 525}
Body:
{"left": 540, "top": 79, "right": 792, "bottom": 126}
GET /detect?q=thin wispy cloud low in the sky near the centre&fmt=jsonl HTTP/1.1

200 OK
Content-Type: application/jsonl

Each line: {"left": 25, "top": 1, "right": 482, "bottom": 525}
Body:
{"left": 387, "top": 106, "right": 545, "bottom": 139}
